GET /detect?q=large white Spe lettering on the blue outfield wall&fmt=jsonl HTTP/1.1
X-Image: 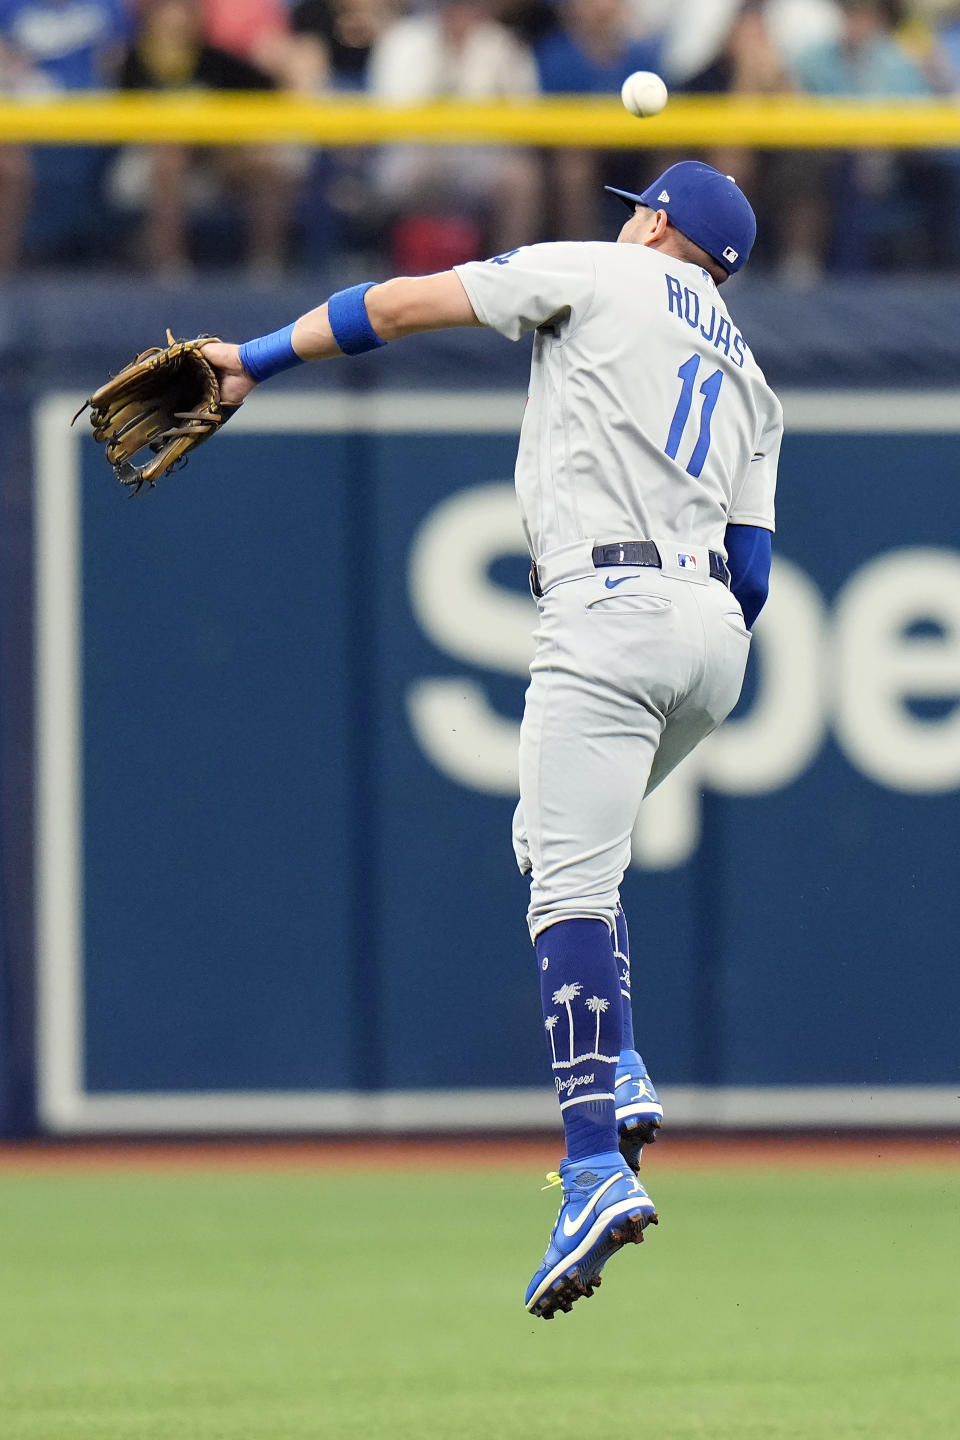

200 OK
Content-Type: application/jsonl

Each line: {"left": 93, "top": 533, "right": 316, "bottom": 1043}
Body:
{"left": 407, "top": 482, "right": 960, "bottom": 868}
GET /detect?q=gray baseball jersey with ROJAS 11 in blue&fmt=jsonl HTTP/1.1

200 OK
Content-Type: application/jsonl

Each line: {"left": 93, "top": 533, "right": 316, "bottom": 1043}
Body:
{"left": 456, "top": 242, "right": 783, "bottom": 559}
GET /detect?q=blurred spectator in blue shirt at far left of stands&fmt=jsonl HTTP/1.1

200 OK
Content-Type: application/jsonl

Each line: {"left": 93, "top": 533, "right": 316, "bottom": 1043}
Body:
{"left": 0, "top": 0, "right": 130, "bottom": 274}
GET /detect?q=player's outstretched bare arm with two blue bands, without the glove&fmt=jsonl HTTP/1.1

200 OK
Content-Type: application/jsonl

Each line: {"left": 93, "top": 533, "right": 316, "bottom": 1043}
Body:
{"left": 203, "top": 271, "right": 479, "bottom": 405}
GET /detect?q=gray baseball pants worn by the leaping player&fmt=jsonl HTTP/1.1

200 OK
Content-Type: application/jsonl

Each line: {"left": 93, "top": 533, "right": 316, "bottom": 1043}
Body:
{"left": 514, "top": 541, "right": 750, "bottom": 940}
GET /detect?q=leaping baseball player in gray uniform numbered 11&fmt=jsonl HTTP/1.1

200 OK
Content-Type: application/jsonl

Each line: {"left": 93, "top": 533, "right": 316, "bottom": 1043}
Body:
{"left": 204, "top": 161, "right": 782, "bottom": 1319}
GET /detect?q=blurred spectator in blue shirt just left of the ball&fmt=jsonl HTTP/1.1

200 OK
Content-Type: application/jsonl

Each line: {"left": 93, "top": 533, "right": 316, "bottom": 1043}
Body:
{"left": 535, "top": 0, "right": 661, "bottom": 240}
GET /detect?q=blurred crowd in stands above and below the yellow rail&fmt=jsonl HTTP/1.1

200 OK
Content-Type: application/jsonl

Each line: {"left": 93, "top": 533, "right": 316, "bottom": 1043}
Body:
{"left": 0, "top": 0, "right": 960, "bottom": 284}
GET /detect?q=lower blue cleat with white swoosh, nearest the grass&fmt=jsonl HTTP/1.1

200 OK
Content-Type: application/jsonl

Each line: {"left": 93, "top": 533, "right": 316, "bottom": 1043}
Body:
{"left": 525, "top": 1151, "right": 658, "bottom": 1320}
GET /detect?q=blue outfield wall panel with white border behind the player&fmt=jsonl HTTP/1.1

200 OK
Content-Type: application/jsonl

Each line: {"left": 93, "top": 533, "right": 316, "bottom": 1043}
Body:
{"left": 0, "top": 277, "right": 960, "bottom": 1132}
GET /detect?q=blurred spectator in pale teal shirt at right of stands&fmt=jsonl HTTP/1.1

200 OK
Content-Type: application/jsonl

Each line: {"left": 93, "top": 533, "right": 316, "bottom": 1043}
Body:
{"left": 784, "top": 0, "right": 954, "bottom": 279}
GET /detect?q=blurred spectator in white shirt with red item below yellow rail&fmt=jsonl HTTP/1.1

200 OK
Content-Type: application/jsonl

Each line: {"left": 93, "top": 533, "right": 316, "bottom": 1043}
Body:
{"left": 368, "top": 0, "right": 541, "bottom": 272}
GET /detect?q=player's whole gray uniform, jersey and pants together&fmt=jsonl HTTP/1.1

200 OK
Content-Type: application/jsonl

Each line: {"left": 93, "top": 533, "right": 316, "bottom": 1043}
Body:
{"left": 456, "top": 242, "right": 783, "bottom": 937}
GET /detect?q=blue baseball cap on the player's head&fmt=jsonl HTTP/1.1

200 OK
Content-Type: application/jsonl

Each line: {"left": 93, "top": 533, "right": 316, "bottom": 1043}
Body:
{"left": 603, "top": 160, "right": 757, "bottom": 275}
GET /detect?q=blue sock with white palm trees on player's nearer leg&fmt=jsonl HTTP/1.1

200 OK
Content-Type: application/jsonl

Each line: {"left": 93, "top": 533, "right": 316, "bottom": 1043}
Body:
{"left": 537, "top": 920, "right": 622, "bottom": 1161}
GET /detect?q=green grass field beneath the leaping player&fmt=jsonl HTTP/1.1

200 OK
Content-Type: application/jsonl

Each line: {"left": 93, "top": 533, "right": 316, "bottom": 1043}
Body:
{"left": 0, "top": 1158, "right": 960, "bottom": 1440}
